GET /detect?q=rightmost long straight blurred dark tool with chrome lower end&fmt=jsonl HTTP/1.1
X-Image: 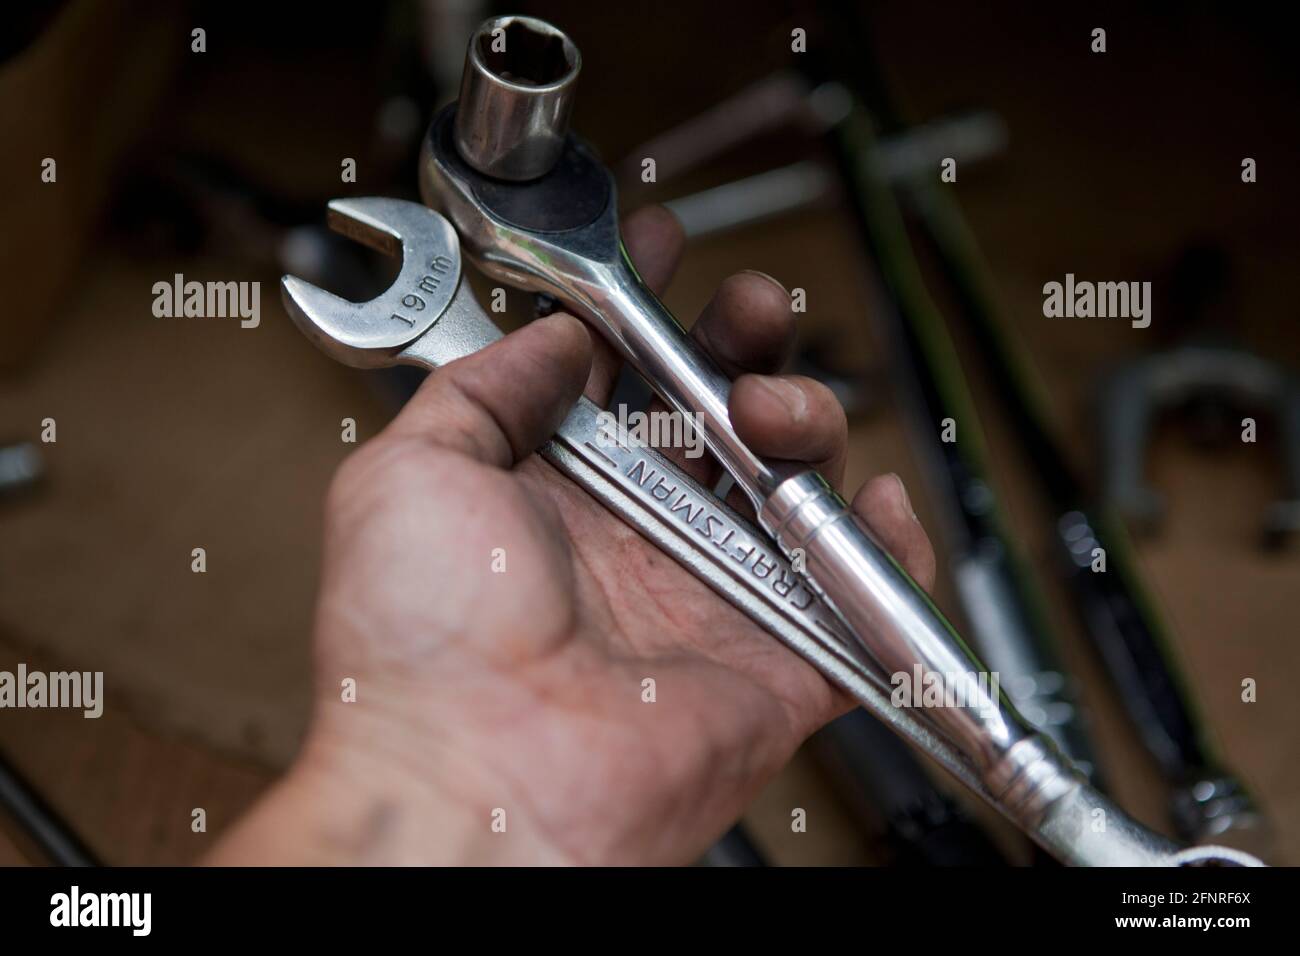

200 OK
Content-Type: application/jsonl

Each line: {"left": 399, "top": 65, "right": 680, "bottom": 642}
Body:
{"left": 824, "top": 0, "right": 1266, "bottom": 847}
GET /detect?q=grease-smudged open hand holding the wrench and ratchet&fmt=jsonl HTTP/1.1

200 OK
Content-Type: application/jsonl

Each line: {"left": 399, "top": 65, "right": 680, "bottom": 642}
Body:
{"left": 213, "top": 209, "right": 935, "bottom": 864}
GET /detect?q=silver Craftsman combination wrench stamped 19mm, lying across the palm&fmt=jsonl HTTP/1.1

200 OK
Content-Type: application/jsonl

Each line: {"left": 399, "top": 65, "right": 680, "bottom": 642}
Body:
{"left": 282, "top": 198, "right": 1252, "bottom": 866}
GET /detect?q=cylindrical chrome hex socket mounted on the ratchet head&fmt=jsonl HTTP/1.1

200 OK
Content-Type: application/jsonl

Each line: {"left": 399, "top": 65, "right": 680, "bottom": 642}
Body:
{"left": 455, "top": 17, "right": 582, "bottom": 182}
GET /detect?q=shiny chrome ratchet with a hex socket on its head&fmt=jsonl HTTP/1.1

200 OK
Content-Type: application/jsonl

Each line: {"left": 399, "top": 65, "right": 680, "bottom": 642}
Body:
{"left": 405, "top": 17, "right": 1252, "bottom": 865}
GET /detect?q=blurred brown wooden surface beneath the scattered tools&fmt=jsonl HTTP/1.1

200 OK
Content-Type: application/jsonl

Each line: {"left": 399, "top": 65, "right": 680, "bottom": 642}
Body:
{"left": 0, "top": 4, "right": 1300, "bottom": 865}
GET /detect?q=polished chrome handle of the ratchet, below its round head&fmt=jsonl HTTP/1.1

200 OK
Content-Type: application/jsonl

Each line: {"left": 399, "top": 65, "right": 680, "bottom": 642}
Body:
{"left": 598, "top": 254, "right": 1078, "bottom": 819}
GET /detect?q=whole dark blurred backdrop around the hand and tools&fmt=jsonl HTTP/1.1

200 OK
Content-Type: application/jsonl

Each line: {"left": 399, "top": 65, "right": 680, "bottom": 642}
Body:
{"left": 0, "top": 0, "right": 1300, "bottom": 864}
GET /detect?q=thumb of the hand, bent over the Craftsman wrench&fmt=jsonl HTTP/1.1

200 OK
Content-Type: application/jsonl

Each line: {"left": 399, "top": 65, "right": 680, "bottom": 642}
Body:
{"left": 386, "top": 312, "right": 592, "bottom": 468}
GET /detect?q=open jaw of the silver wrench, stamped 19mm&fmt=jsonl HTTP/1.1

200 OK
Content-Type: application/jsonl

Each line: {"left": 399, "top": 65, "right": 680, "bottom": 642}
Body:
{"left": 280, "top": 196, "right": 460, "bottom": 368}
